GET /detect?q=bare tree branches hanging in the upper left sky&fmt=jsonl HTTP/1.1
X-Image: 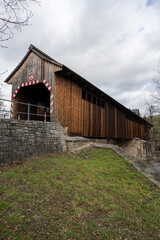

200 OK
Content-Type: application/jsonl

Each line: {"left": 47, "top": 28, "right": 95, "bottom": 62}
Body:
{"left": 0, "top": 0, "right": 39, "bottom": 47}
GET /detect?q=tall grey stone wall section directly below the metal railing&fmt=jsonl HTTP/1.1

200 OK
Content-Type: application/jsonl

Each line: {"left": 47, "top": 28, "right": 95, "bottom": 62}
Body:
{"left": 0, "top": 119, "right": 66, "bottom": 165}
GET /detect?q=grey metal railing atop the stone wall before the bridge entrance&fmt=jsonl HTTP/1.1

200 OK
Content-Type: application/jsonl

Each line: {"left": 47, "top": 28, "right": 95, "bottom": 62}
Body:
{"left": 0, "top": 98, "right": 52, "bottom": 121}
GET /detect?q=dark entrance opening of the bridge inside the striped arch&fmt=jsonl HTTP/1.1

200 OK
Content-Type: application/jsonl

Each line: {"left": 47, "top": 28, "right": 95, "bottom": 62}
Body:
{"left": 13, "top": 83, "right": 50, "bottom": 121}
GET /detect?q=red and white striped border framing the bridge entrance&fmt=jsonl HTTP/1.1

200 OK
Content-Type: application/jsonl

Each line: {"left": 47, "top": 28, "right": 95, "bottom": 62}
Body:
{"left": 10, "top": 80, "right": 53, "bottom": 118}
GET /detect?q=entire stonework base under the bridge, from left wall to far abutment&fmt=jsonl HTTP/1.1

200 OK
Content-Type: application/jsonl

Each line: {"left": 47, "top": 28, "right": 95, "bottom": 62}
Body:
{"left": 0, "top": 119, "right": 154, "bottom": 165}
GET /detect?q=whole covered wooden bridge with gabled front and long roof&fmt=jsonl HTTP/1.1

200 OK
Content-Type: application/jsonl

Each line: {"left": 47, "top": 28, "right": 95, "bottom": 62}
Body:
{"left": 5, "top": 45, "right": 152, "bottom": 139}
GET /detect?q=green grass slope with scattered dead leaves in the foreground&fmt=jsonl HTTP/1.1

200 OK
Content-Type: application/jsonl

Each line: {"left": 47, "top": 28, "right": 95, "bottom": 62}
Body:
{"left": 0, "top": 149, "right": 160, "bottom": 240}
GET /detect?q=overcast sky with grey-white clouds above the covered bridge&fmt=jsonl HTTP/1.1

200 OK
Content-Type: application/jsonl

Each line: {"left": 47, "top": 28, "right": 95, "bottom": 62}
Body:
{"left": 0, "top": 0, "right": 160, "bottom": 113}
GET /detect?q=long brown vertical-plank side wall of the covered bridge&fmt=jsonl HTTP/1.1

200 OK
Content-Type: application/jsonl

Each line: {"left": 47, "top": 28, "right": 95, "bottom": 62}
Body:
{"left": 54, "top": 73, "right": 149, "bottom": 139}
